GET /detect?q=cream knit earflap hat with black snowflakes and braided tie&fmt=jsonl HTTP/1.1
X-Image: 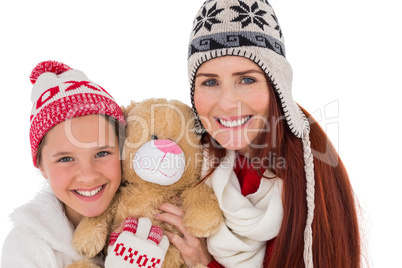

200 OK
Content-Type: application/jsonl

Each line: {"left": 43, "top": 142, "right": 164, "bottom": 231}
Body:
{"left": 188, "top": 0, "right": 314, "bottom": 268}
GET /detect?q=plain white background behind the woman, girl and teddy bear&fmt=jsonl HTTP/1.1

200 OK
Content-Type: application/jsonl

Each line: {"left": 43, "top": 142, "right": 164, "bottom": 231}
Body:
{"left": 0, "top": 0, "right": 402, "bottom": 267}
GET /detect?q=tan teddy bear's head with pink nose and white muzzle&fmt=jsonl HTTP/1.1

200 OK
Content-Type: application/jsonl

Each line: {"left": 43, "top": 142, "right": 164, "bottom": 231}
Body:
{"left": 122, "top": 99, "right": 202, "bottom": 189}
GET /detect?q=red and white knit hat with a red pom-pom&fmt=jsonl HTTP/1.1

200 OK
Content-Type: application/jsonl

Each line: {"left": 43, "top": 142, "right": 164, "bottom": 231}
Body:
{"left": 29, "top": 61, "right": 126, "bottom": 167}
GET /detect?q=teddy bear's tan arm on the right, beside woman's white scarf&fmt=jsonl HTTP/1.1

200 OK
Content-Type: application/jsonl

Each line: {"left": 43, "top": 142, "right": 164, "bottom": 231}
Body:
{"left": 182, "top": 184, "right": 223, "bottom": 237}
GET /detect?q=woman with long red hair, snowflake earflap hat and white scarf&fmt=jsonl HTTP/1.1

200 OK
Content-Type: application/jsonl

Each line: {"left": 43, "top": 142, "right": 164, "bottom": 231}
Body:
{"left": 160, "top": 0, "right": 360, "bottom": 268}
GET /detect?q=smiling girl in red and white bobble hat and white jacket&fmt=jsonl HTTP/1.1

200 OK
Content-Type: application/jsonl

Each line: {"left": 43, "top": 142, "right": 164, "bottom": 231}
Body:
{"left": 1, "top": 61, "right": 166, "bottom": 268}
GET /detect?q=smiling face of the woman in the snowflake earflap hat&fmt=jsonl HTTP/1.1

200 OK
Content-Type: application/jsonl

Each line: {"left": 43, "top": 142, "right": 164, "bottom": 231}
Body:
{"left": 194, "top": 56, "right": 272, "bottom": 154}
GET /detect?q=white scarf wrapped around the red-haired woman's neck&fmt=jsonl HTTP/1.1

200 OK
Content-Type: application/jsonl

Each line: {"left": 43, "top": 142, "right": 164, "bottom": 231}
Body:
{"left": 203, "top": 150, "right": 283, "bottom": 268}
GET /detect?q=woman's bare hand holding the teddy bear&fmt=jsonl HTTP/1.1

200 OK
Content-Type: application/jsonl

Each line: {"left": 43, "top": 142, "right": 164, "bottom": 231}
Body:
{"left": 155, "top": 203, "right": 212, "bottom": 267}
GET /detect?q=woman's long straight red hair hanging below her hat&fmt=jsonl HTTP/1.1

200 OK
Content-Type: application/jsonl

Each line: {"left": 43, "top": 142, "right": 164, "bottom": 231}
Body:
{"left": 203, "top": 84, "right": 361, "bottom": 268}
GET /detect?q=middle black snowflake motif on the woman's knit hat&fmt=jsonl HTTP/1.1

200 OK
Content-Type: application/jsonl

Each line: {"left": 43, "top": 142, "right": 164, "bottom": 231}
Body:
{"left": 230, "top": 0, "right": 269, "bottom": 30}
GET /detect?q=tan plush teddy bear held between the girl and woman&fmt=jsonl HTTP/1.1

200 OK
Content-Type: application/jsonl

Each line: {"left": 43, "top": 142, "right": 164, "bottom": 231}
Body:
{"left": 69, "top": 99, "right": 223, "bottom": 268}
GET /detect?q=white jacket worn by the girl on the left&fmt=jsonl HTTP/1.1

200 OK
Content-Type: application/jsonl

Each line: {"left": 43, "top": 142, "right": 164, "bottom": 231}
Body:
{"left": 1, "top": 186, "right": 102, "bottom": 268}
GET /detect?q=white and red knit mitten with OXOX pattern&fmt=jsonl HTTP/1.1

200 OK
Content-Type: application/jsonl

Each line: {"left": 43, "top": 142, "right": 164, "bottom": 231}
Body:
{"left": 105, "top": 218, "right": 169, "bottom": 268}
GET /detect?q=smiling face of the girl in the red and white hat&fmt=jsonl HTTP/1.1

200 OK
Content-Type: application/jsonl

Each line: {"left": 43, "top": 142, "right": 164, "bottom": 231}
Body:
{"left": 39, "top": 115, "right": 121, "bottom": 226}
